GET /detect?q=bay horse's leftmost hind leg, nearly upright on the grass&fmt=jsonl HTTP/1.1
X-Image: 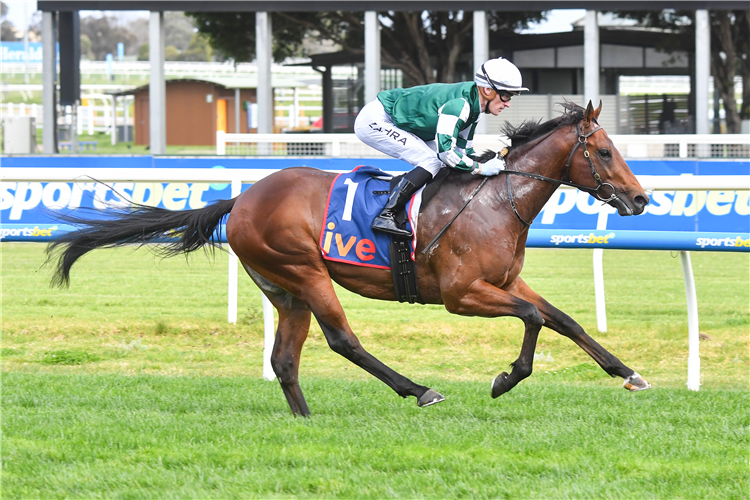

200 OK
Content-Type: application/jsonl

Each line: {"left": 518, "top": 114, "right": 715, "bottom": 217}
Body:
{"left": 243, "top": 264, "right": 311, "bottom": 417}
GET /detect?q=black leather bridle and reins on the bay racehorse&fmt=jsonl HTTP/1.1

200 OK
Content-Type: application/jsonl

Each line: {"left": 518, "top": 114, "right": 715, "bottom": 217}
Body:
{"left": 422, "top": 123, "right": 633, "bottom": 255}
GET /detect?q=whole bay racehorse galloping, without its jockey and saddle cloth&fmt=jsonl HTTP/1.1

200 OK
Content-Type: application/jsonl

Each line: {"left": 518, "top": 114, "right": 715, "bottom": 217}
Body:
{"left": 47, "top": 102, "right": 650, "bottom": 416}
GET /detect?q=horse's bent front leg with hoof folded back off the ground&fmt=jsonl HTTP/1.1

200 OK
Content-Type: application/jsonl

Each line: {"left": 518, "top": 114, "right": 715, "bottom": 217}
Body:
{"left": 442, "top": 280, "right": 544, "bottom": 398}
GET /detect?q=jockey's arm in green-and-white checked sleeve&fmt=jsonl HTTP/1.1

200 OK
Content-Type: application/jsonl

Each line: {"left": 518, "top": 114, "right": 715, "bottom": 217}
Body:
{"left": 435, "top": 98, "right": 477, "bottom": 171}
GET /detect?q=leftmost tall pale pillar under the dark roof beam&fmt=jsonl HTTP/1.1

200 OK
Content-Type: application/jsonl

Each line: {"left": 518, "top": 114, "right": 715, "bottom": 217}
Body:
{"left": 42, "top": 12, "right": 57, "bottom": 154}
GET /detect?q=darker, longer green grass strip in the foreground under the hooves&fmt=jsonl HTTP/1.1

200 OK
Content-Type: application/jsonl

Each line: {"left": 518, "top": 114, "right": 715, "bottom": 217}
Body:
{"left": 2, "top": 373, "right": 750, "bottom": 499}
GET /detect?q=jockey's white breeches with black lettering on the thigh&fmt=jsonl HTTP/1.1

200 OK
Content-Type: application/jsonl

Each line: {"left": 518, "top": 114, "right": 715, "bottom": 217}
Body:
{"left": 354, "top": 99, "right": 446, "bottom": 177}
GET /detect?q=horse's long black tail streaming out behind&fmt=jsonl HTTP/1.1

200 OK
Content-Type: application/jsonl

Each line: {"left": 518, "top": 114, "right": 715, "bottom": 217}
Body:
{"left": 47, "top": 199, "right": 235, "bottom": 288}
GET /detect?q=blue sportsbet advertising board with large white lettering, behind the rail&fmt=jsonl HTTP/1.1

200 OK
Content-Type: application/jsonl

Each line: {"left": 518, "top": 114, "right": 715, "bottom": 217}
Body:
{"left": 0, "top": 156, "right": 750, "bottom": 245}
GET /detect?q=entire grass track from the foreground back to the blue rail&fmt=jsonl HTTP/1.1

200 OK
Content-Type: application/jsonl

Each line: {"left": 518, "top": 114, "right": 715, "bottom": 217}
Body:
{"left": 0, "top": 243, "right": 750, "bottom": 499}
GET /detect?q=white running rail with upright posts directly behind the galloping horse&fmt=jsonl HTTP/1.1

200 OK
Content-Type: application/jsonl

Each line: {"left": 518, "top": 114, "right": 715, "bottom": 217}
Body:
{"left": 0, "top": 166, "right": 750, "bottom": 391}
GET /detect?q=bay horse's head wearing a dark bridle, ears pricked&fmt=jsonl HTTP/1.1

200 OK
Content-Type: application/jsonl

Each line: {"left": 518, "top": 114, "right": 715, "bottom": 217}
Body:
{"left": 566, "top": 101, "right": 649, "bottom": 215}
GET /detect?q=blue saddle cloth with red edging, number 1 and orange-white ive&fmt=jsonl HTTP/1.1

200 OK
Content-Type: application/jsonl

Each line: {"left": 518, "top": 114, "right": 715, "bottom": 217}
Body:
{"left": 320, "top": 165, "right": 422, "bottom": 269}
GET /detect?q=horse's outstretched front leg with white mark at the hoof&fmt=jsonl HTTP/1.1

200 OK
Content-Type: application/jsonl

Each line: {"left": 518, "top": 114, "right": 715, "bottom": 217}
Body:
{"left": 507, "top": 278, "right": 651, "bottom": 391}
